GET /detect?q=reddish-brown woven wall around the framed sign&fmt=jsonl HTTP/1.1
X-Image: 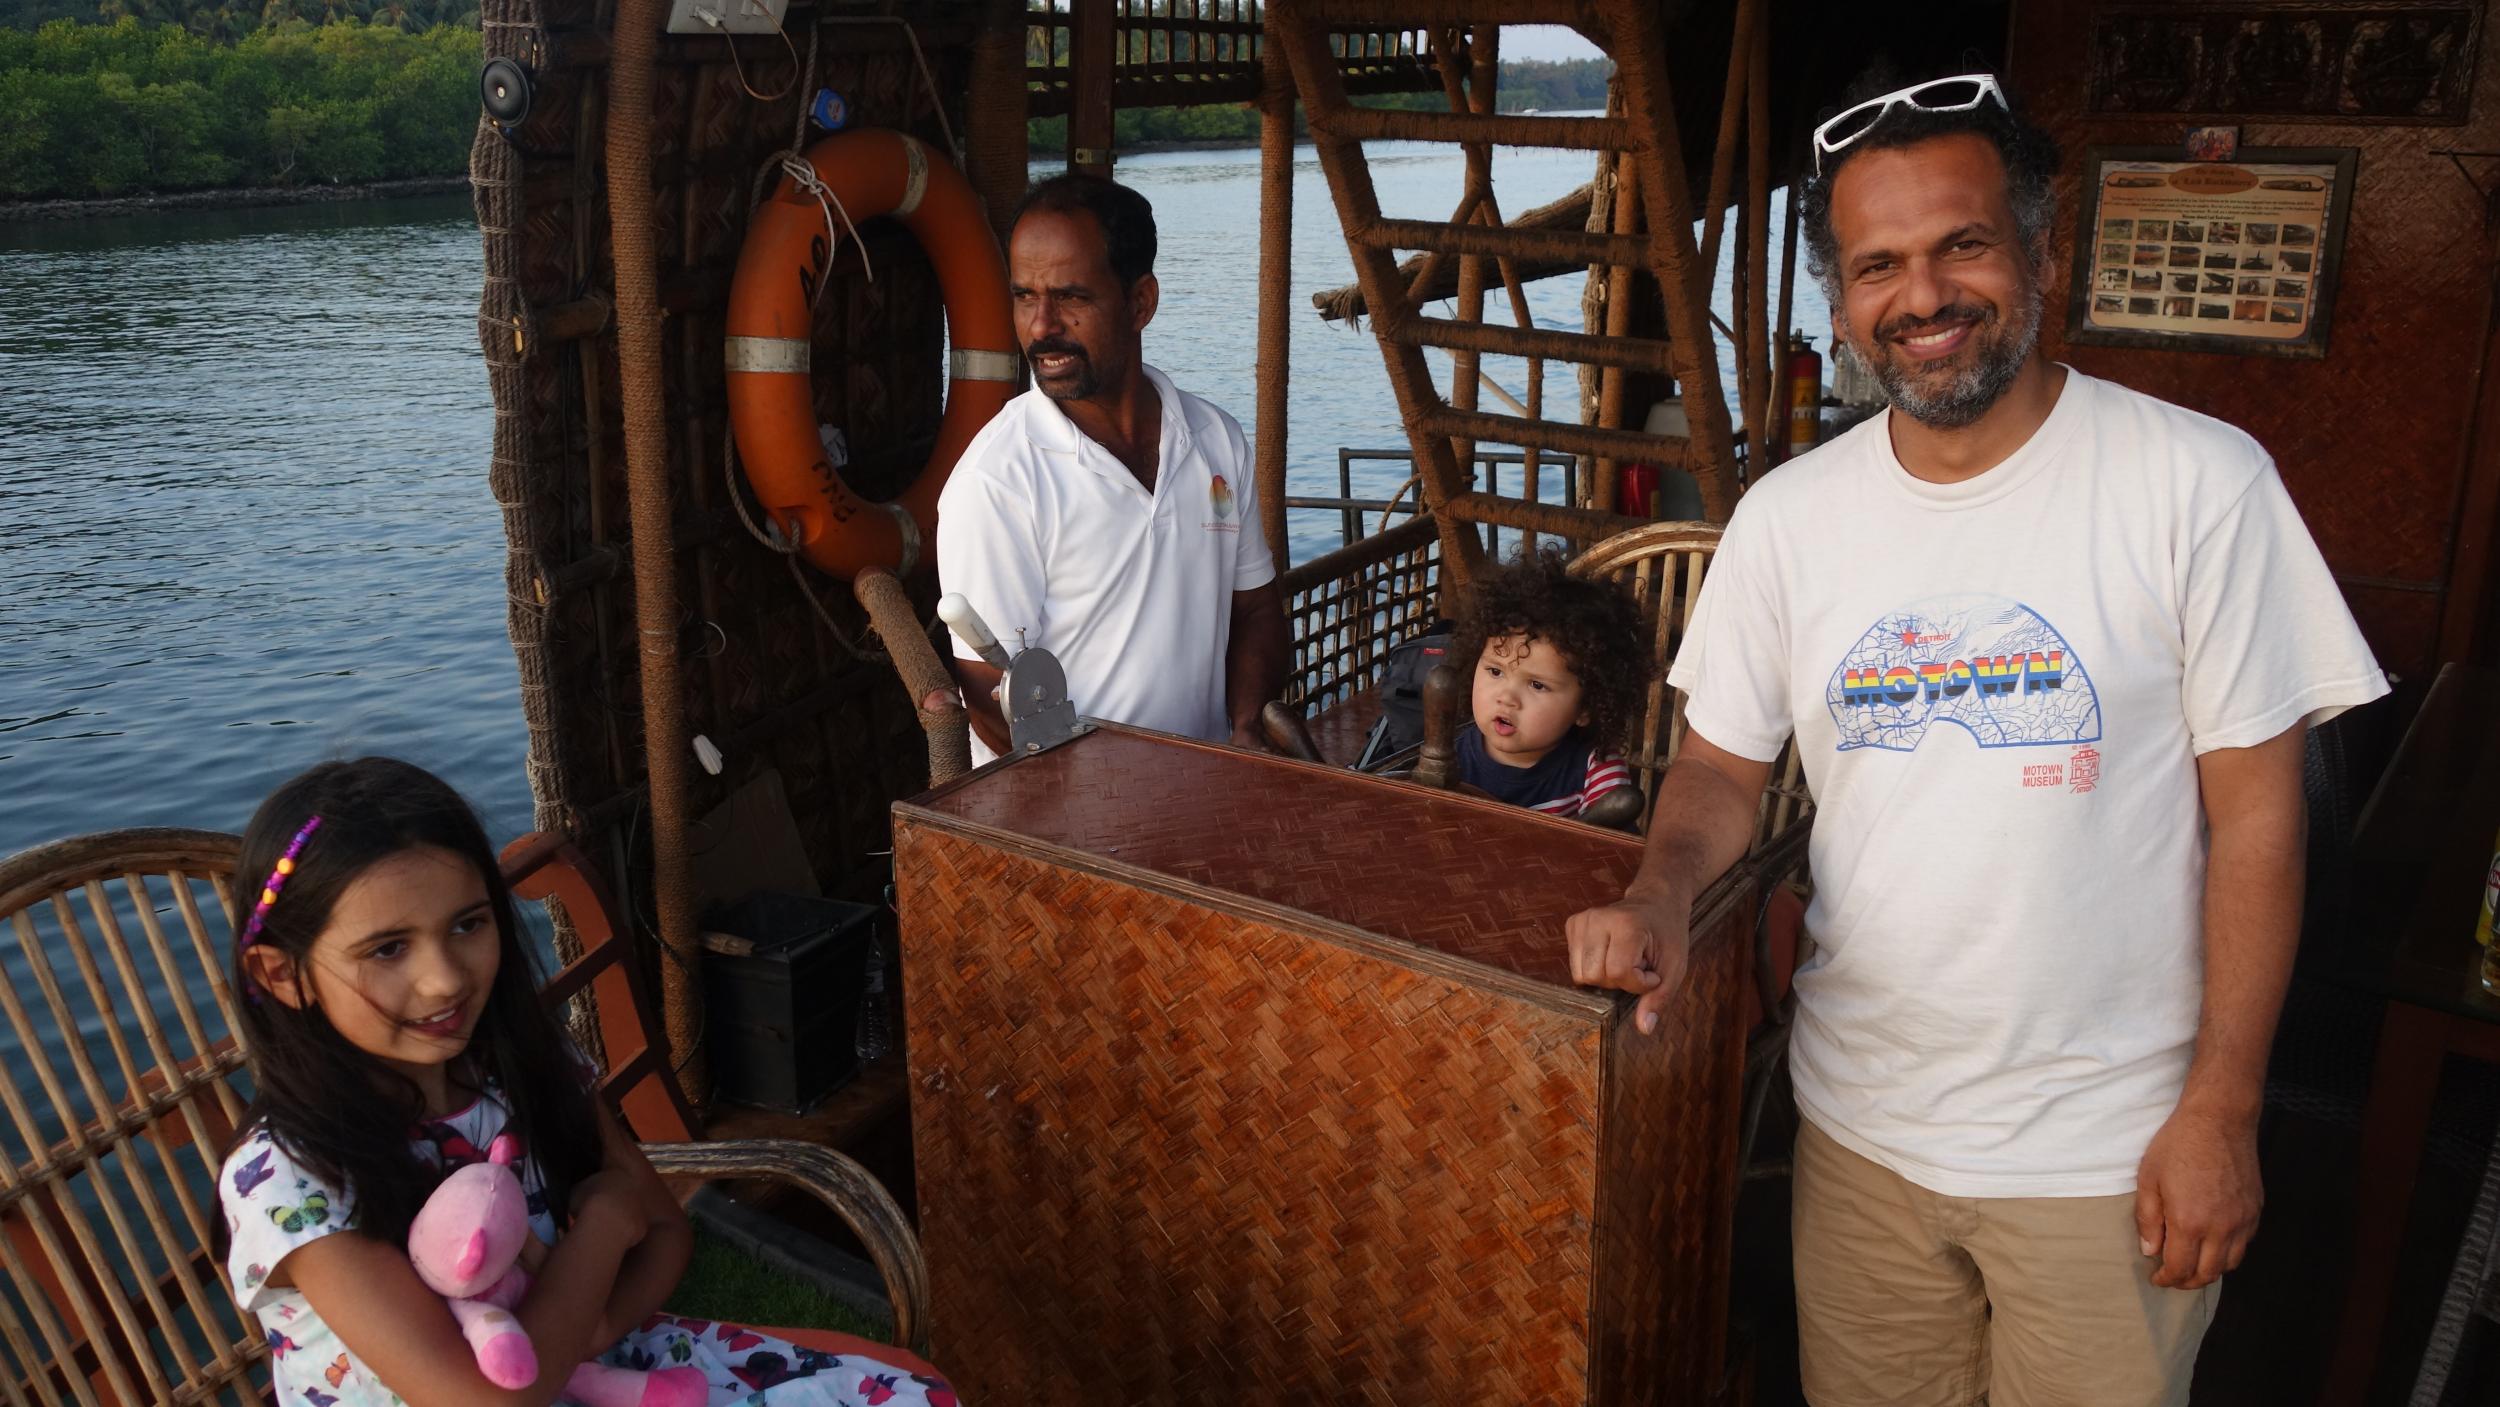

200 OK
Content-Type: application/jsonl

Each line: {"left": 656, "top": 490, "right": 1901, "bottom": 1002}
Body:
{"left": 2010, "top": 0, "right": 2500, "bottom": 675}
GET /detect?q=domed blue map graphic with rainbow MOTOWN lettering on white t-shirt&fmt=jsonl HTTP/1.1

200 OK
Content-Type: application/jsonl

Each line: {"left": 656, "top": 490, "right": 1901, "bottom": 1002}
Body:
{"left": 1825, "top": 592, "right": 2100, "bottom": 752}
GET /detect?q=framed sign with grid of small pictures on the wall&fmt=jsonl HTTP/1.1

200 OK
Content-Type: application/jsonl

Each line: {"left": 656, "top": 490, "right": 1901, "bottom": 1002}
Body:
{"left": 2065, "top": 147, "right": 2358, "bottom": 357}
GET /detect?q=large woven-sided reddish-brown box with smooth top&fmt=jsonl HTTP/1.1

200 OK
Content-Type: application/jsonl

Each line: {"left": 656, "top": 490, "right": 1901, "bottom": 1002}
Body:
{"left": 895, "top": 727, "right": 1755, "bottom": 1407}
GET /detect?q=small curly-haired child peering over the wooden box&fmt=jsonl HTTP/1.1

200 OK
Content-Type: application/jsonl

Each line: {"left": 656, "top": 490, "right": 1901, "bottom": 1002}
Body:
{"left": 1450, "top": 550, "right": 1650, "bottom": 817}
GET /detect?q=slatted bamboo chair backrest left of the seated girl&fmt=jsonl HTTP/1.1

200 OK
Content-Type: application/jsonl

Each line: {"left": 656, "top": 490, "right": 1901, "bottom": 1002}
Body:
{"left": 0, "top": 830, "right": 260, "bottom": 1407}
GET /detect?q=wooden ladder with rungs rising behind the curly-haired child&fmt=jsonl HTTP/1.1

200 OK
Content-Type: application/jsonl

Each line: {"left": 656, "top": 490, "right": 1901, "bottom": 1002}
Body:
{"left": 1265, "top": 0, "right": 1738, "bottom": 585}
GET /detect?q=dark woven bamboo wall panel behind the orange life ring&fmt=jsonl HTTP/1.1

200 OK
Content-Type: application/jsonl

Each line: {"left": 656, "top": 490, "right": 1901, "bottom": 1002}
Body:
{"left": 473, "top": 0, "right": 985, "bottom": 914}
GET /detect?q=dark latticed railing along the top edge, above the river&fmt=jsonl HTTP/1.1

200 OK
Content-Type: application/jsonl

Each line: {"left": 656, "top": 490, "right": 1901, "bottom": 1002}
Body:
{"left": 1025, "top": 0, "right": 1438, "bottom": 117}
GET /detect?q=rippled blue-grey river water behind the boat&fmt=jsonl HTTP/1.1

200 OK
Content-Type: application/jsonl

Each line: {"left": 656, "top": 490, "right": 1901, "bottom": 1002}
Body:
{"left": 0, "top": 147, "right": 1828, "bottom": 855}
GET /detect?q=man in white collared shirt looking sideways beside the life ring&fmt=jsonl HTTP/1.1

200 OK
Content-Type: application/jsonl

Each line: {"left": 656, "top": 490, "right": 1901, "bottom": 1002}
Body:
{"left": 938, "top": 175, "right": 1290, "bottom": 762}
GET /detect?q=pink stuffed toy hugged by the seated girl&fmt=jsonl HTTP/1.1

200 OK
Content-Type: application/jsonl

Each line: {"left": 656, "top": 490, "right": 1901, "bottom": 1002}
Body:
{"left": 408, "top": 1135, "right": 710, "bottom": 1407}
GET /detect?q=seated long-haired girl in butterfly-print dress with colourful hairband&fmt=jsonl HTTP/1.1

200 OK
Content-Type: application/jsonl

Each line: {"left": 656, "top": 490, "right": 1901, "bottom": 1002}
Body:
{"left": 218, "top": 757, "right": 955, "bottom": 1407}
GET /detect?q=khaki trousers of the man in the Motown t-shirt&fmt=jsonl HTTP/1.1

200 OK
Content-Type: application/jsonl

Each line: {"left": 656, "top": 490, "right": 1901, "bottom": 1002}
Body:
{"left": 1793, "top": 1122, "right": 2223, "bottom": 1407}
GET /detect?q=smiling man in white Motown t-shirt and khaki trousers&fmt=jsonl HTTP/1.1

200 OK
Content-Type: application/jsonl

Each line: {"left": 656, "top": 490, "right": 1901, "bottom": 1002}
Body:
{"left": 1568, "top": 75, "right": 2388, "bottom": 1407}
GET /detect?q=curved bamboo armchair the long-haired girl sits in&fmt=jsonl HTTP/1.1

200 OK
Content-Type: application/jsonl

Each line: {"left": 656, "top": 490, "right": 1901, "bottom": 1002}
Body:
{"left": 0, "top": 830, "right": 928, "bottom": 1407}
